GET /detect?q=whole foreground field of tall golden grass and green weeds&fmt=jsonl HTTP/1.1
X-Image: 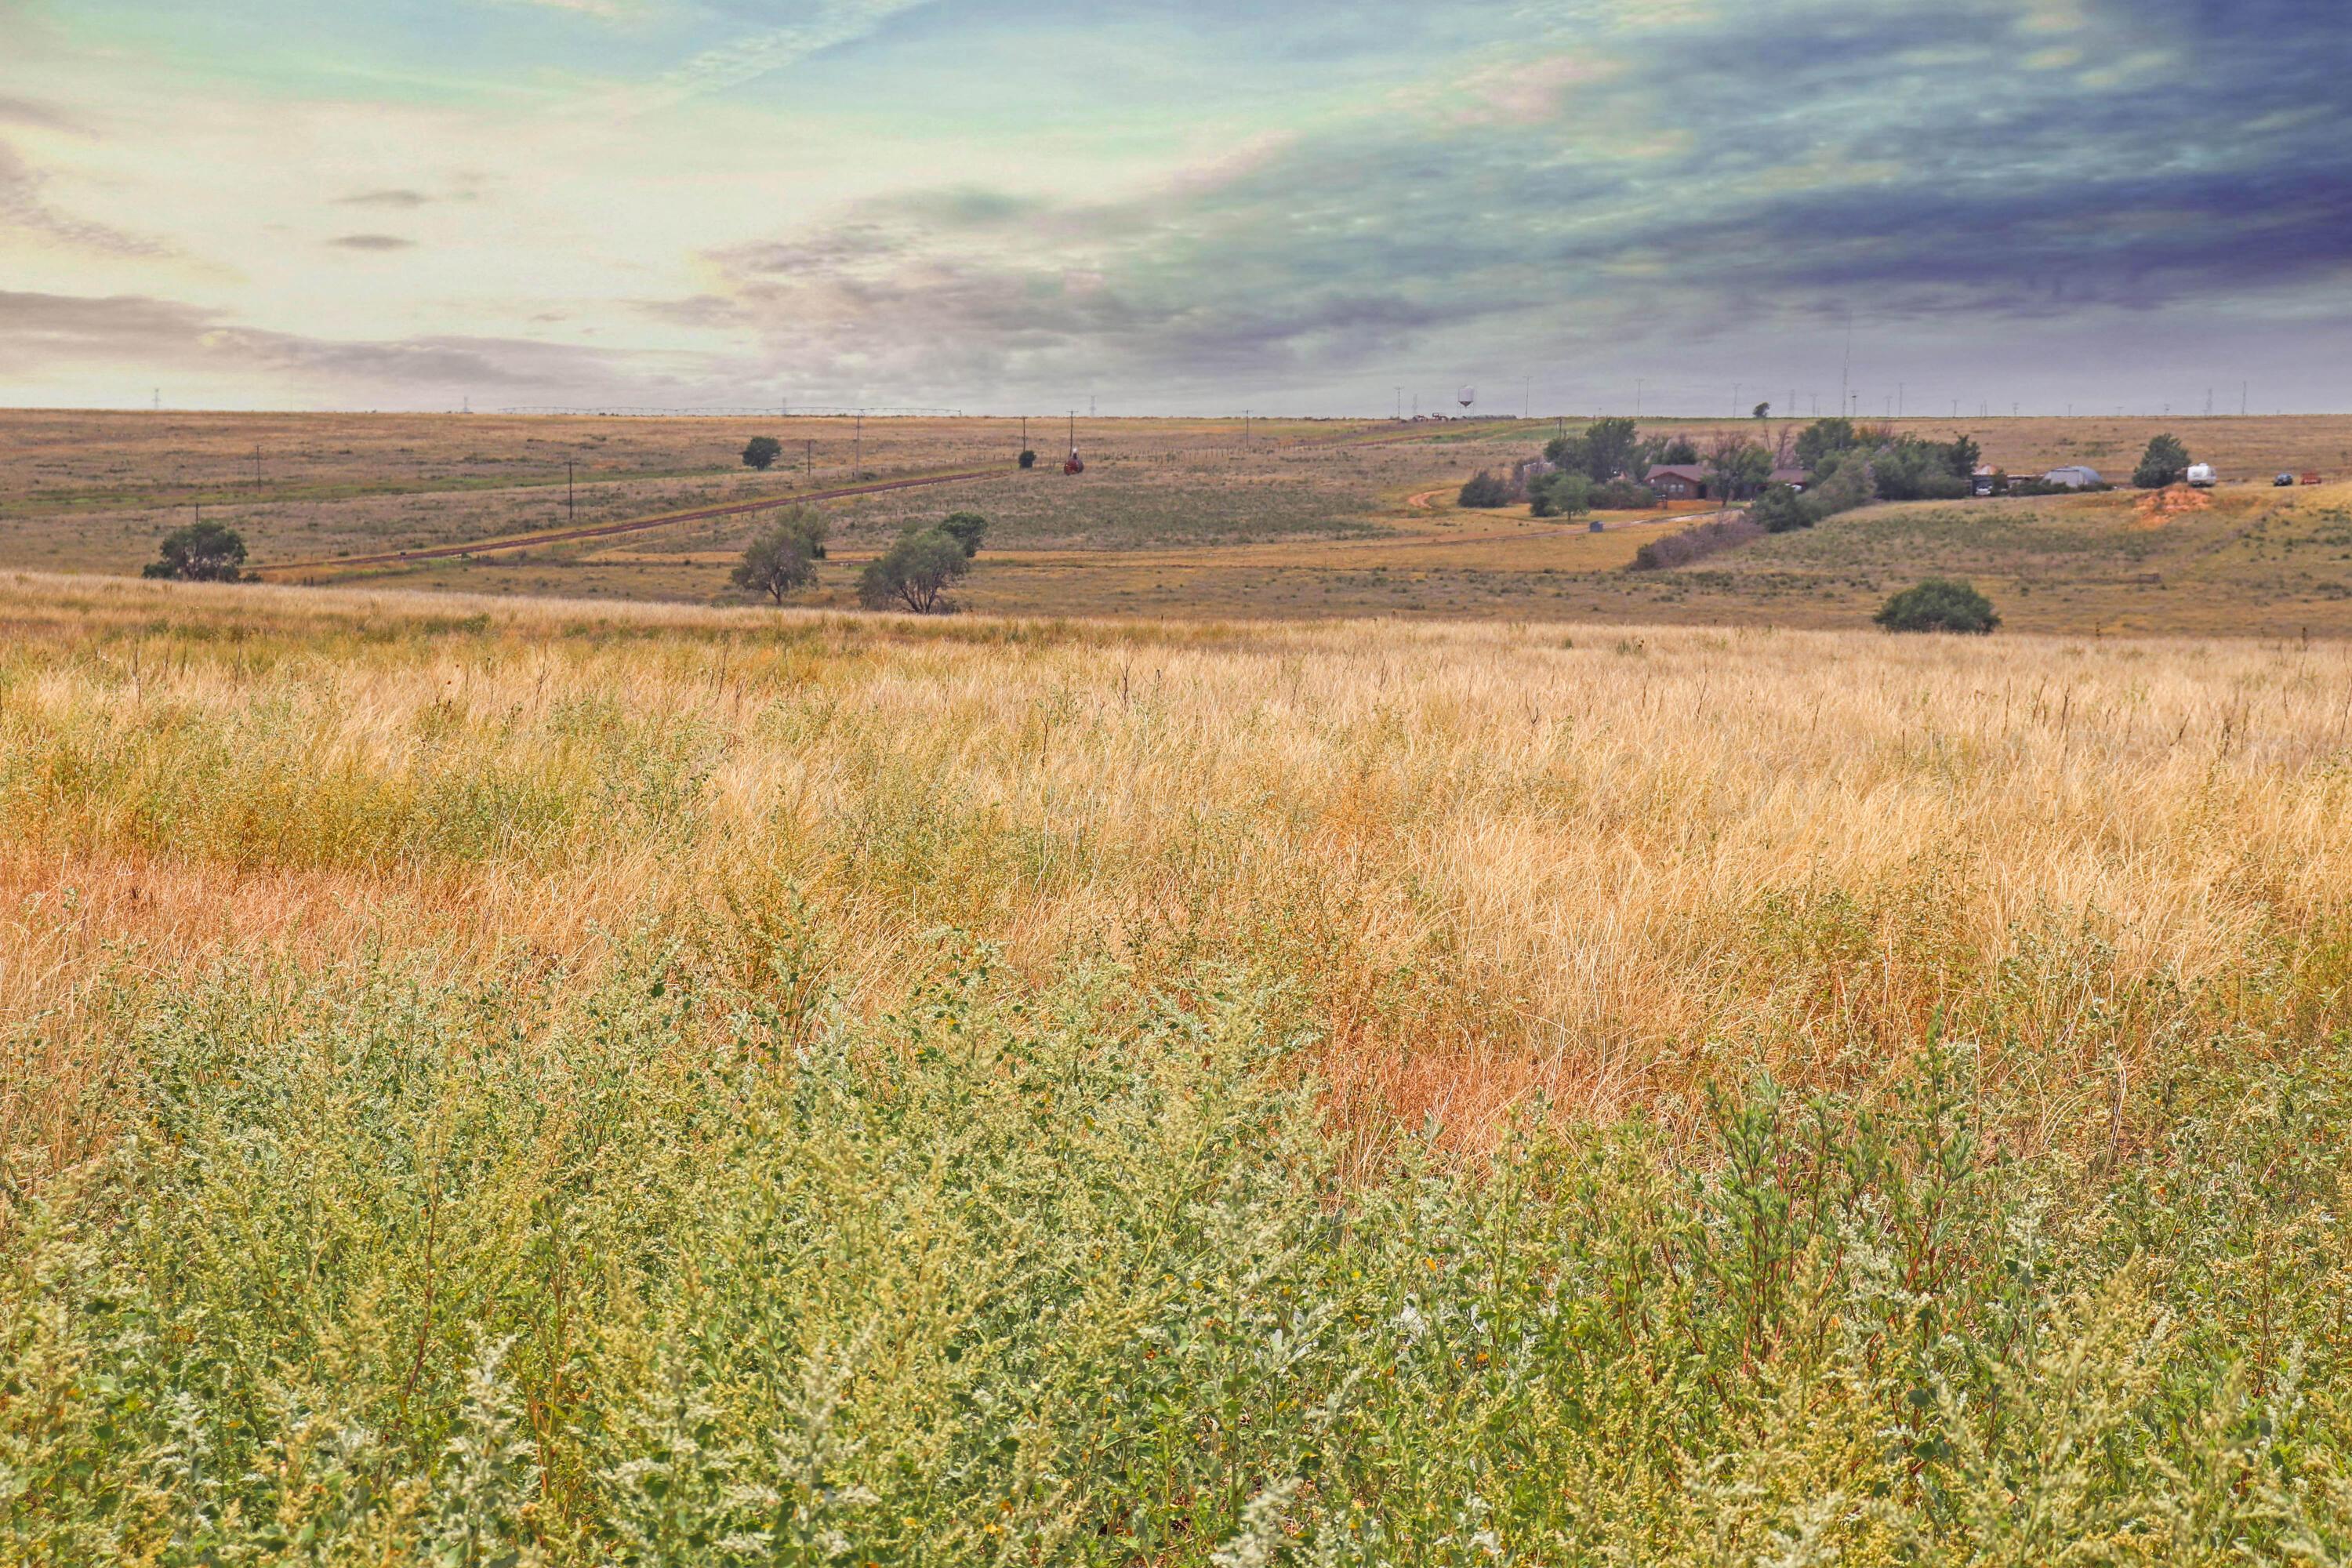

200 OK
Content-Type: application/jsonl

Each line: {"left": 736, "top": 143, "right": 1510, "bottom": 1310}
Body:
{"left": 0, "top": 573, "right": 2352, "bottom": 1568}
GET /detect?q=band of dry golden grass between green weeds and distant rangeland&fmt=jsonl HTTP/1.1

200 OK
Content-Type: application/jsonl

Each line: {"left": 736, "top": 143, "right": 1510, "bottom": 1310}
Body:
{"left": 0, "top": 576, "right": 2352, "bottom": 1185}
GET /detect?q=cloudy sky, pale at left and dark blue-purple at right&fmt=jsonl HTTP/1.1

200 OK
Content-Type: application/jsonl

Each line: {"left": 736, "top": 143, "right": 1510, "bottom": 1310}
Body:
{"left": 0, "top": 0, "right": 2352, "bottom": 416}
